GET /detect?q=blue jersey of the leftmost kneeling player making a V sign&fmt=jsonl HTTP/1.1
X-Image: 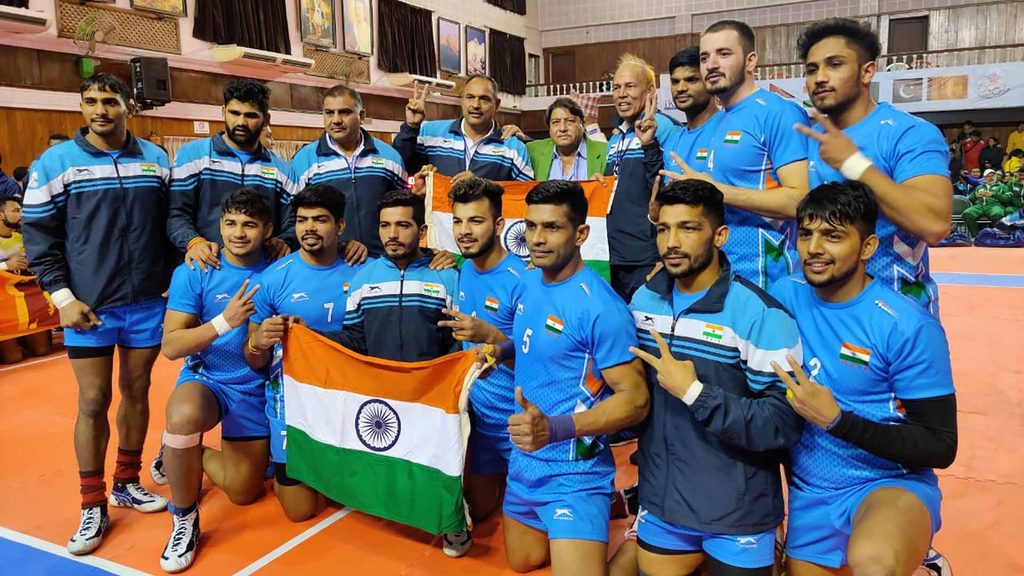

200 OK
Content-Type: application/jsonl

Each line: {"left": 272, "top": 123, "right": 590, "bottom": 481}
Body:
{"left": 167, "top": 257, "right": 266, "bottom": 393}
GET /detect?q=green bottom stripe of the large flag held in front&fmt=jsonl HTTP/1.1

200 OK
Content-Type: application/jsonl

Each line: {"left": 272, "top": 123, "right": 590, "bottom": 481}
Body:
{"left": 288, "top": 426, "right": 466, "bottom": 534}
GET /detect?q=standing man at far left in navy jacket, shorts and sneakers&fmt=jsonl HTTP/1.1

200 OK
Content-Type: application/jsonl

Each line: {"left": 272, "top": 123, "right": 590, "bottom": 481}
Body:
{"left": 23, "top": 74, "right": 172, "bottom": 554}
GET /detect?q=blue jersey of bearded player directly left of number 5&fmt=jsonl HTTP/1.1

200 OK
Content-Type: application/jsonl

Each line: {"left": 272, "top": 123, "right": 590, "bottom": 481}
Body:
{"left": 456, "top": 252, "right": 526, "bottom": 427}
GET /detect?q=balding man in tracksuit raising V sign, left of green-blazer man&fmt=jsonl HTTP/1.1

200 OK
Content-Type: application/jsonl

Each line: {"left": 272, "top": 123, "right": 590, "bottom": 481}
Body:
{"left": 394, "top": 75, "right": 534, "bottom": 180}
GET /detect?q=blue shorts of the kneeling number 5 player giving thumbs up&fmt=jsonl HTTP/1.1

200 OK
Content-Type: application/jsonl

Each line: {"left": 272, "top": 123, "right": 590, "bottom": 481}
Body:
{"left": 502, "top": 479, "right": 614, "bottom": 542}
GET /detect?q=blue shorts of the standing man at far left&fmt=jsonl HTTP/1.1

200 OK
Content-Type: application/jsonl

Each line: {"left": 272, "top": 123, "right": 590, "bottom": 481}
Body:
{"left": 65, "top": 298, "right": 167, "bottom": 348}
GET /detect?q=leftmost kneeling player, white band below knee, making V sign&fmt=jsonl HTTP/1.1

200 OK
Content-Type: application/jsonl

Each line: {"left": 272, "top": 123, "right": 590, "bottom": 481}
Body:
{"left": 160, "top": 189, "right": 273, "bottom": 572}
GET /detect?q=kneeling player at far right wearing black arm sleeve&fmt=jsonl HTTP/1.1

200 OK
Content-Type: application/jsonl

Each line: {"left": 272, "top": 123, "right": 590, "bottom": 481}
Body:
{"left": 772, "top": 181, "right": 956, "bottom": 576}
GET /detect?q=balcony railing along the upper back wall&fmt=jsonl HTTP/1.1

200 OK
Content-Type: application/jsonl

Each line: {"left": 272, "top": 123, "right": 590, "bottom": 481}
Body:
{"left": 526, "top": 44, "right": 1024, "bottom": 97}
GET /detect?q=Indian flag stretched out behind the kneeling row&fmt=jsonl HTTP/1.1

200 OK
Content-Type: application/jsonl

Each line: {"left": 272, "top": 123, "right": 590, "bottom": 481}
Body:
{"left": 427, "top": 174, "right": 610, "bottom": 280}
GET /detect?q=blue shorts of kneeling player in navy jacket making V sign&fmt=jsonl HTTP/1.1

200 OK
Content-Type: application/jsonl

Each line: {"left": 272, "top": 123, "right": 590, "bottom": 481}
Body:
{"left": 637, "top": 507, "right": 775, "bottom": 569}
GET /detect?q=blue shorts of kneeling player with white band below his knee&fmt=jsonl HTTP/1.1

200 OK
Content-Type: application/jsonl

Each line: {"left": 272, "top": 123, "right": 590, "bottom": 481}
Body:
{"left": 174, "top": 365, "right": 270, "bottom": 442}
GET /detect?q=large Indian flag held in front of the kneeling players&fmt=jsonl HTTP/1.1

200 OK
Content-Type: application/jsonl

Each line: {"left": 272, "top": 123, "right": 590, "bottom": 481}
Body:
{"left": 283, "top": 326, "right": 478, "bottom": 534}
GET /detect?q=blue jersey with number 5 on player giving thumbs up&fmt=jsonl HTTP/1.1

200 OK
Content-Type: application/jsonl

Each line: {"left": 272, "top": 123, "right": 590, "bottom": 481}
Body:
{"left": 499, "top": 268, "right": 637, "bottom": 493}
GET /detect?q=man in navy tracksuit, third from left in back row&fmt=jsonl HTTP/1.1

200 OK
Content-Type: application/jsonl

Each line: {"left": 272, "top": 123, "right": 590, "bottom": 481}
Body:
{"left": 291, "top": 84, "right": 406, "bottom": 256}
